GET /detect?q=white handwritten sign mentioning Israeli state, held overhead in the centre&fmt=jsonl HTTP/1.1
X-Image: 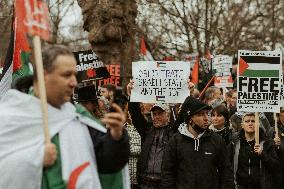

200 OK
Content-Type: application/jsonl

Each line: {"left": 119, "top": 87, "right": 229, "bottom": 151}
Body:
{"left": 130, "top": 61, "right": 190, "bottom": 103}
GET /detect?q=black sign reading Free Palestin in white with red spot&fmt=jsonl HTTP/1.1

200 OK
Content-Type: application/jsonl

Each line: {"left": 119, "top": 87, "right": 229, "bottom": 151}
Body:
{"left": 73, "top": 50, "right": 109, "bottom": 83}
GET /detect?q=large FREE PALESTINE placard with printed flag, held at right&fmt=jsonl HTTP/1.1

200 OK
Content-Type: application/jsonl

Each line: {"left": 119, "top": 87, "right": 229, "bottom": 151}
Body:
{"left": 237, "top": 50, "right": 282, "bottom": 112}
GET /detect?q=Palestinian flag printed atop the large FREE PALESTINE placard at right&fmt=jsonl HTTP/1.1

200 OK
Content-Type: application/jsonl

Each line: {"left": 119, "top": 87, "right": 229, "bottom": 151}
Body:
{"left": 238, "top": 56, "right": 281, "bottom": 77}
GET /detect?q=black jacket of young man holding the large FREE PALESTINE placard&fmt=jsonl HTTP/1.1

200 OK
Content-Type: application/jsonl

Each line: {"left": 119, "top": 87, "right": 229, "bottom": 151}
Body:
{"left": 231, "top": 129, "right": 279, "bottom": 189}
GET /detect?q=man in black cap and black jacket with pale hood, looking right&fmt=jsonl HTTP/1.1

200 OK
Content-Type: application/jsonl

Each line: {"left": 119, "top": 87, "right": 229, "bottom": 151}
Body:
{"left": 161, "top": 97, "right": 233, "bottom": 189}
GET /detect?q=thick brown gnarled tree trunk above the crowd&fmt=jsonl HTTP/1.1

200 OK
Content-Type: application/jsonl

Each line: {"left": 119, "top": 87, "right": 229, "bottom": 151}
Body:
{"left": 78, "top": 0, "right": 137, "bottom": 84}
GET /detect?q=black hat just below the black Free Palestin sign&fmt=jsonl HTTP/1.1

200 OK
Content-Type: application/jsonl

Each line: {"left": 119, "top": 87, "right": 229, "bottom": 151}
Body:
{"left": 77, "top": 85, "right": 98, "bottom": 102}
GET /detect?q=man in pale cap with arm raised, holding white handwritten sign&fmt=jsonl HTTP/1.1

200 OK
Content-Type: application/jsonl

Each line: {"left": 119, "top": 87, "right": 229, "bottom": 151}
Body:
{"left": 127, "top": 82, "right": 173, "bottom": 189}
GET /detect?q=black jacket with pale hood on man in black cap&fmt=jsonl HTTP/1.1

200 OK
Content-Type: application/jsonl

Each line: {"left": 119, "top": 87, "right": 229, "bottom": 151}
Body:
{"left": 162, "top": 125, "right": 233, "bottom": 189}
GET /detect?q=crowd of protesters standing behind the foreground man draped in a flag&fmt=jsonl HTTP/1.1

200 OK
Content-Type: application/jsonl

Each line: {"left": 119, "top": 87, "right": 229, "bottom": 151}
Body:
{"left": 76, "top": 81, "right": 284, "bottom": 189}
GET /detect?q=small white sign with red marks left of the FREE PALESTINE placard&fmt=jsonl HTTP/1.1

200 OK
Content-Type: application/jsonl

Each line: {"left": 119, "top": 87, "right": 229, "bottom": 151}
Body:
{"left": 212, "top": 55, "right": 233, "bottom": 88}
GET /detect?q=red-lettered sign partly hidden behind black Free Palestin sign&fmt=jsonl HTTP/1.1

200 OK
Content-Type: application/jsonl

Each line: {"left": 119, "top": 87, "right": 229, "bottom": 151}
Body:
{"left": 97, "top": 64, "right": 121, "bottom": 87}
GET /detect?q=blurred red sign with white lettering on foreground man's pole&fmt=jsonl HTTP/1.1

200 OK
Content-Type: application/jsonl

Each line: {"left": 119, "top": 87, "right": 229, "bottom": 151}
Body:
{"left": 15, "top": 0, "right": 49, "bottom": 40}
